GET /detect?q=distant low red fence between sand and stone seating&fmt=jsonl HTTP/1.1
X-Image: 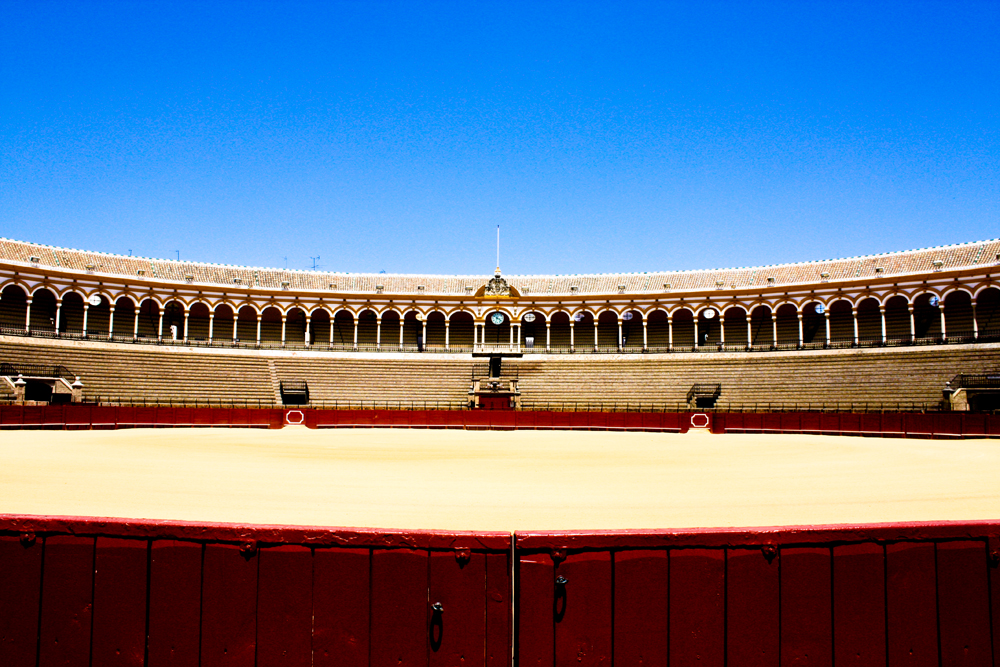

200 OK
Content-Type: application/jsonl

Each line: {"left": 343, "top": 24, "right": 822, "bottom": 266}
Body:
{"left": 0, "top": 405, "right": 1000, "bottom": 438}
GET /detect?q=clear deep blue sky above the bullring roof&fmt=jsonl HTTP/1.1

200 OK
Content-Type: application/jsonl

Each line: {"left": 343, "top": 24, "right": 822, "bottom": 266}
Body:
{"left": 0, "top": 0, "right": 1000, "bottom": 274}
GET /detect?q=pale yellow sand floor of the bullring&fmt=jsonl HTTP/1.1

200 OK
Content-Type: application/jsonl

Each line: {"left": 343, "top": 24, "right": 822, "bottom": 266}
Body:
{"left": 0, "top": 429, "right": 1000, "bottom": 530}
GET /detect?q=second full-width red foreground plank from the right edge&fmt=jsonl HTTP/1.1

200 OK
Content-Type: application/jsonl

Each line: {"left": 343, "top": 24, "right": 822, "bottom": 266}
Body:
{"left": 885, "top": 542, "right": 938, "bottom": 667}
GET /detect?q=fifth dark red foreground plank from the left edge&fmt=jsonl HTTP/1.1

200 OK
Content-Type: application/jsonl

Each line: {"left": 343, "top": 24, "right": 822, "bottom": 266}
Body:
{"left": 201, "top": 544, "right": 257, "bottom": 667}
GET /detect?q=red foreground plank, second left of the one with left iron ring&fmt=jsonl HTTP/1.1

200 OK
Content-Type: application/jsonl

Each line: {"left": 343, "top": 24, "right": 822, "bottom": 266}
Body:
{"left": 313, "top": 549, "right": 371, "bottom": 667}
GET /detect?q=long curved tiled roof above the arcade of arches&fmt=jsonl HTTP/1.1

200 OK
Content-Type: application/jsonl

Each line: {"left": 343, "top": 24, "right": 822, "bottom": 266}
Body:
{"left": 0, "top": 239, "right": 1000, "bottom": 296}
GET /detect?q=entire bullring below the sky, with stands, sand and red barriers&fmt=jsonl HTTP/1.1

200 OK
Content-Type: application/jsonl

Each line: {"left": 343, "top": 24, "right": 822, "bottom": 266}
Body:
{"left": 0, "top": 240, "right": 1000, "bottom": 667}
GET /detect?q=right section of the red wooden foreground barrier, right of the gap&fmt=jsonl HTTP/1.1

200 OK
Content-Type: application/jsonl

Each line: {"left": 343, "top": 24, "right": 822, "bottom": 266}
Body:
{"left": 516, "top": 522, "right": 1000, "bottom": 667}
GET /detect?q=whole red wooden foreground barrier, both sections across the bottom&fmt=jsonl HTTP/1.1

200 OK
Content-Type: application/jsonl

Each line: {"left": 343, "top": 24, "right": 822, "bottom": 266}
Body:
{"left": 0, "top": 515, "right": 1000, "bottom": 667}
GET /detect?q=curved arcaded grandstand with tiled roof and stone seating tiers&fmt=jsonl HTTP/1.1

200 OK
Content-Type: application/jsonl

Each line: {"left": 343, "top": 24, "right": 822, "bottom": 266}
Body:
{"left": 0, "top": 239, "right": 1000, "bottom": 410}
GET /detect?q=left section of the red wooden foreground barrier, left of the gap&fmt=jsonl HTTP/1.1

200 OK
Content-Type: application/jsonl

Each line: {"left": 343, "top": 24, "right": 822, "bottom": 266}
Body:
{"left": 0, "top": 516, "right": 511, "bottom": 667}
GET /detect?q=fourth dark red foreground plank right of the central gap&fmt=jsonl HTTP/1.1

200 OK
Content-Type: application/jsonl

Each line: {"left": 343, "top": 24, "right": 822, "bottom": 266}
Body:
{"left": 670, "top": 549, "right": 726, "bottom": 667}
